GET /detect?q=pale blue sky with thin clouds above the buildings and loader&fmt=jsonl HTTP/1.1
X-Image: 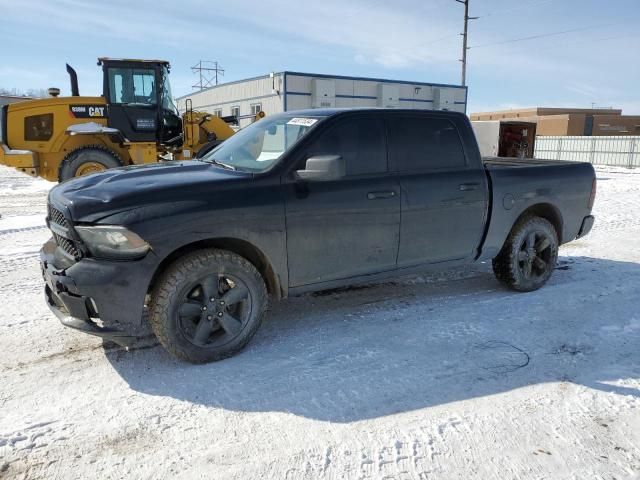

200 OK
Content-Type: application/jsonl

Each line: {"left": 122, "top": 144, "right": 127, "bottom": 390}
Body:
{"left": 0, "top": 0, "right": 640, "bottom": 114}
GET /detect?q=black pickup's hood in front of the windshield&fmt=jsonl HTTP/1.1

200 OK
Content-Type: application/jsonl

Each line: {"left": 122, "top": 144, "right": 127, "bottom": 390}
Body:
{"left": 49, "top": 160, "right": 253, "bottom": 222}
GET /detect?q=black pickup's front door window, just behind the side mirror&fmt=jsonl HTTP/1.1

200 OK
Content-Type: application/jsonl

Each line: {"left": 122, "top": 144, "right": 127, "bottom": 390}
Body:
{"left": 307, "top": 118, "right": 387, "bottom": 176}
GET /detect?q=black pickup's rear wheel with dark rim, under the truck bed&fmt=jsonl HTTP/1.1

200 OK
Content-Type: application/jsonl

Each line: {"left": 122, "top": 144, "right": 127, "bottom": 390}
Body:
{"left": 492, "top": 216, "right": 558, "bottom": 292}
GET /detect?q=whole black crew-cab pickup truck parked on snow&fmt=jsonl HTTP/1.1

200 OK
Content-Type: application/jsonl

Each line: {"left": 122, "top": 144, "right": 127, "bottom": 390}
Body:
{"left": 41, "top": 109, "right": 596, "bottom": 362}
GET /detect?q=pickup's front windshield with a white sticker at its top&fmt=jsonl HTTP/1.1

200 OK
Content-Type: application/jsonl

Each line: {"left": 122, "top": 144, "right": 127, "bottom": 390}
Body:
{"left": 201, "top": 115, "right": 323, "bottom": 172}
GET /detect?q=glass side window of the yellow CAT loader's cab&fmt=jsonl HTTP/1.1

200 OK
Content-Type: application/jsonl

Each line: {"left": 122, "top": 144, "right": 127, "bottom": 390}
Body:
{"left": 109, "top": 68, "right": 157, "bottom": 105}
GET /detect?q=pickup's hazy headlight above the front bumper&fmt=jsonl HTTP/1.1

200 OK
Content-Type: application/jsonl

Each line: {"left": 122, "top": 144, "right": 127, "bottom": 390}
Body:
{"left": 75, "top": 225, "right": 149, "bottom": 259}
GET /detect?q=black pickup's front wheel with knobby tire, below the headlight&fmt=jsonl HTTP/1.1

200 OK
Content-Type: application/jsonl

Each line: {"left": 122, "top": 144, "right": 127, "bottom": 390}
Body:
{"left": 149, "top": 249, "right": 268, "bottom": 363}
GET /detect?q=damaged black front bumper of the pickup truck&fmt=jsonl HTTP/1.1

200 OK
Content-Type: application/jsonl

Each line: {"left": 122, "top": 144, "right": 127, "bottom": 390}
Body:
{"left": 40, "top": 240, "right": 152, "bottom": 346}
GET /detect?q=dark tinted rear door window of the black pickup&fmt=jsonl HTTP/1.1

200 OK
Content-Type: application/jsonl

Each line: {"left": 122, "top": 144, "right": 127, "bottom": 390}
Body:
{"left": 388, "top": 115, "right": 466, "bottom": 172}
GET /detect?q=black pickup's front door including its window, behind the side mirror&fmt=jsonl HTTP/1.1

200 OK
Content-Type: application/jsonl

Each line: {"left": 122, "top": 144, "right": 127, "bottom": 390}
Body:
{"left": 285, "top": 114, "right": 400, "bottom": 287}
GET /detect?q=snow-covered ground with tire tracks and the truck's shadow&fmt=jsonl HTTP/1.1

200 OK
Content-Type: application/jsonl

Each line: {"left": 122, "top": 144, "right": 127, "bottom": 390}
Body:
{"left": 0, "top": 163, "right": 640, "bottom": 480}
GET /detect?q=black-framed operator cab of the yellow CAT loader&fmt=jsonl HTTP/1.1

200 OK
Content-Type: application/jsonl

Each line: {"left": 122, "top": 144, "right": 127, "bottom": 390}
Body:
{"left": 98, "top": 58, "right": 182, "bottom": 146}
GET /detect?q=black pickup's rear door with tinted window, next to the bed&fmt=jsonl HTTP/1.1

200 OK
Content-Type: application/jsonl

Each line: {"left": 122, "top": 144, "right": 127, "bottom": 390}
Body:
{"left": 387, "top": 113, "right": 487, "bottom": 267}
